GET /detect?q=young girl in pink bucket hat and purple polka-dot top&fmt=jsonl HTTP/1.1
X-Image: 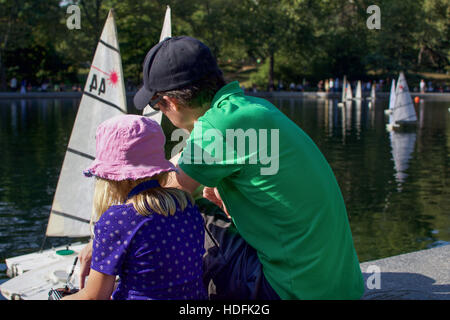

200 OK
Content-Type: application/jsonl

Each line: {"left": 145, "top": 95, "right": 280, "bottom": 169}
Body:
{"left": 64, "top": 115, "right": 207, "bottom": 300}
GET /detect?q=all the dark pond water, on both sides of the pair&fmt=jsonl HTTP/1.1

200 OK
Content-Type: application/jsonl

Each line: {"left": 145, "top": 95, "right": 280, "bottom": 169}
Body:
{"left": 0, "top": 95, "right": 450, "bottom": 282}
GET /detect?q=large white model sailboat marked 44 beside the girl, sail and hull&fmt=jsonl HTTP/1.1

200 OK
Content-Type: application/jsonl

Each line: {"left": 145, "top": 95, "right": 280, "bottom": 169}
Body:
{"left": 0, "top": 10, "right": 127, "bottom": 300}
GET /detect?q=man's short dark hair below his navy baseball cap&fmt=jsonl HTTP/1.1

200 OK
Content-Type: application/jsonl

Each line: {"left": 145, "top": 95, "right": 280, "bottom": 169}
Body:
{"left": 156, "top": 74, "right": 225, "bottom": 108}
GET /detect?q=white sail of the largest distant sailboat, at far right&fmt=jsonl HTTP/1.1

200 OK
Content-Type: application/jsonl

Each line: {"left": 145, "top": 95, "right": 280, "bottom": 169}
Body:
{"left": 393, "top": 72, "right": 417, "bottom": 123}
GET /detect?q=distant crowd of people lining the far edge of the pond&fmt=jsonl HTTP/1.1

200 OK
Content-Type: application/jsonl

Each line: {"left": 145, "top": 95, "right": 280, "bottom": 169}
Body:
{"left": 4, "top": 77, "right": 450, "bottom": 93}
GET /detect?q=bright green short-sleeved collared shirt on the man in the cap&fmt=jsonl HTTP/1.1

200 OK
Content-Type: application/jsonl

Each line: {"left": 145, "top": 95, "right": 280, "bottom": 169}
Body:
{"left": 179, "top": 81, "right": 364, "bottom": 299}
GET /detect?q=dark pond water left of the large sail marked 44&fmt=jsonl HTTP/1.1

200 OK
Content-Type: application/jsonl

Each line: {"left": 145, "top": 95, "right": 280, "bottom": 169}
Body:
{"left": 0, "top": 99, "right": 80, "bottom": 260}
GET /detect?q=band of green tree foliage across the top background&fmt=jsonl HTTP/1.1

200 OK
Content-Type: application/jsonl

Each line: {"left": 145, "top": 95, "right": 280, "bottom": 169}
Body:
{"left": 0, "top": 0, "right": 450, "bottom": 88}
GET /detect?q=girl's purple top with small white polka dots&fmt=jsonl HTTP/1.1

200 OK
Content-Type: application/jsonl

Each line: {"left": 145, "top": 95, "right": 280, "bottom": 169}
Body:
{"left": 91, "top": 204, "right": 207, "bottom": 300}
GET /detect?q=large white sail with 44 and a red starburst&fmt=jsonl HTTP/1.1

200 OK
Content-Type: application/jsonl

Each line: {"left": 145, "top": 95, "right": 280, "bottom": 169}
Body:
{"left": 46, "top": 10, "right": 127, "bottom": 237}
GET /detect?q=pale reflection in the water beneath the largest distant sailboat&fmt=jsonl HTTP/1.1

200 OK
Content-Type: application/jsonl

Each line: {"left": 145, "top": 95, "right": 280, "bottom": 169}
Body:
{"left": 390, "top": 131, "right": 416, "bottom": 186}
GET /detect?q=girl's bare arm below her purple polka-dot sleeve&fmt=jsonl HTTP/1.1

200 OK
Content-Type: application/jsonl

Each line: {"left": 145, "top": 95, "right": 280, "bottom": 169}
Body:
{"left": 62, "top": 269, "right": 116, "bottom": 300}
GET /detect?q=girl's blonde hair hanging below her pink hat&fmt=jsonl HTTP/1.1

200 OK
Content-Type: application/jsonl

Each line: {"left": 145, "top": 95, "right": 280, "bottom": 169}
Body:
{"left": 91, "top": 172, "right": 194, "bottom": 224}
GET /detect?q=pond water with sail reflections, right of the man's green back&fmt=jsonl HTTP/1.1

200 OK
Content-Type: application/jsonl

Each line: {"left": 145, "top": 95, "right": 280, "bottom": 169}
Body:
{"left": 274, "top": 95, "right": 450, "bottom": 261}
